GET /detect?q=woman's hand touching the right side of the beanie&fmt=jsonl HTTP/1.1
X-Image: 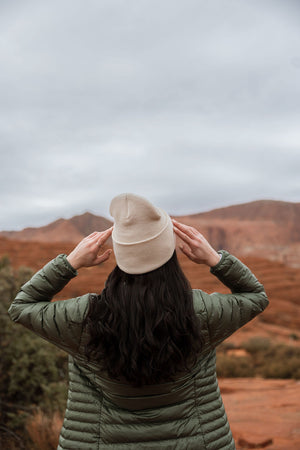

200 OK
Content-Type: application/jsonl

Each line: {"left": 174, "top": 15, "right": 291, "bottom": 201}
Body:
{"left": 172, "top": 220, "right": 221, "bottom": 267}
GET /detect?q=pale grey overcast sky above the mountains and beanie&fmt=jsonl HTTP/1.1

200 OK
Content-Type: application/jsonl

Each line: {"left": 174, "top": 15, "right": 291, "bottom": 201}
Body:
{"left": 0, "top": 0, "right": 300, "bottom": 230}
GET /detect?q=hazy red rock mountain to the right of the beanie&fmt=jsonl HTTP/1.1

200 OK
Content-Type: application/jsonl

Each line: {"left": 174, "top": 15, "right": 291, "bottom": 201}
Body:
{"left": 179, "top": 200, "right": 300, "bottom": 267}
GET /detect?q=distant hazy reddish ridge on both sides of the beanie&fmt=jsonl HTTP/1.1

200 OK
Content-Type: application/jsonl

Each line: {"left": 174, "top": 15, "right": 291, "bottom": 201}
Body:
{"left": 0, "top": 200, "right": 300, "bottom": 267}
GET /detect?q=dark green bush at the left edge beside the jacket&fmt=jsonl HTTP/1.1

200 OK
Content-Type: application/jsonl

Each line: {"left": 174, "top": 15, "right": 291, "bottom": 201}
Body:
{"left": 0, "top": 257, "right": 67, "bottom": 450}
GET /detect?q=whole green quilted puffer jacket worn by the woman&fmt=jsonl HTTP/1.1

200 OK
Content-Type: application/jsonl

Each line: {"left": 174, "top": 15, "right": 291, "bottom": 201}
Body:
{"left": 9, "top": 251, "right": 268, "bottom": 450}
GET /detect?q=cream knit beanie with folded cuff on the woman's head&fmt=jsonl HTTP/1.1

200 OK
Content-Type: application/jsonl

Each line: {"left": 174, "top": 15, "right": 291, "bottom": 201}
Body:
{"left": 109, "top": 194, "right": 175, "bottom": 274}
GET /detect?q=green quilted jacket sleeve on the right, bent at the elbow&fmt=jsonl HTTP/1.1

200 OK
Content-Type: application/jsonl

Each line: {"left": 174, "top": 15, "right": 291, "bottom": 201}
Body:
{"left": 194, "top": 250, "right": 269, "bottom": 347}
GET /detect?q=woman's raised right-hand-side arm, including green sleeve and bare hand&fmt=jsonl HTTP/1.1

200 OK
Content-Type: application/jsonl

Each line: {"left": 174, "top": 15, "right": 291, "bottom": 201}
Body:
{"left": 174, "top": 222, "right": 269, "bottom": 347}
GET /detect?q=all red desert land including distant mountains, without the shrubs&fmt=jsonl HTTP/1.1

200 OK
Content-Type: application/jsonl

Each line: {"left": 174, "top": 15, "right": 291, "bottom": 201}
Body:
{"left": 0, "top": 201, "right": 300, "bottom": 450}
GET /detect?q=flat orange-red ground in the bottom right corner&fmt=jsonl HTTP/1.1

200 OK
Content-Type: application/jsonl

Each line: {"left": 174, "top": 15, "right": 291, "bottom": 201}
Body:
{"left": 219, "top": 378, "right": 300, "bottom": 450}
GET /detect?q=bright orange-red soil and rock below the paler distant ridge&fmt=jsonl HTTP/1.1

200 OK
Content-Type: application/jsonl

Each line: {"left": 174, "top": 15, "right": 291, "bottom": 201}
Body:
{"left": 0, "top": 238, "right": 300, "bottom": 450}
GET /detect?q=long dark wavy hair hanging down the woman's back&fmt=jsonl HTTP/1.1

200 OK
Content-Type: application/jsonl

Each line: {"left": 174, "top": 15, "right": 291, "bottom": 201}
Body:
{"left": 85, "top": 252, "right": 203, "bottom": 386}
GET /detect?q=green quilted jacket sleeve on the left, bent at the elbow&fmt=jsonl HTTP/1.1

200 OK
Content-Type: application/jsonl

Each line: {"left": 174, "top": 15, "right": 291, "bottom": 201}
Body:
{"left": 8, "top": 255, "right": 89, "bottom": 354}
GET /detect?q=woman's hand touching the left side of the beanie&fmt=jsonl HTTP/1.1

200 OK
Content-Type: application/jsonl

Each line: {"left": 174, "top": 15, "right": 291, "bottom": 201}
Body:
{"left": 67, "top": 227, "right": 113, "bottom": 270}
